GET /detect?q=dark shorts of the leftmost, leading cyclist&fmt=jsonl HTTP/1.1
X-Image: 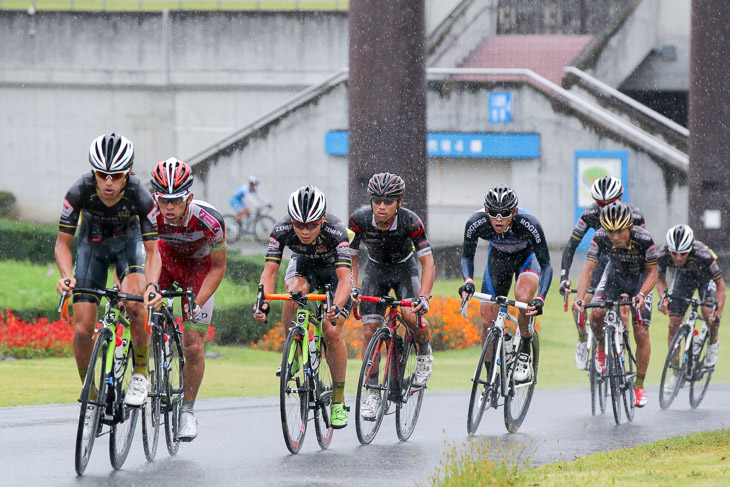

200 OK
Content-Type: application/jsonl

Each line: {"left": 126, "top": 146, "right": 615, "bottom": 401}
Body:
{"left": 74, "top": 230, "right": 147, "bottom": 304}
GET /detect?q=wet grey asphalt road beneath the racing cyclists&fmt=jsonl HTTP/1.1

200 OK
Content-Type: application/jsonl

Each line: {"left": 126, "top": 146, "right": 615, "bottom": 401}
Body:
{"left": 0, "top": 384, "right": 730, "bottom": 487}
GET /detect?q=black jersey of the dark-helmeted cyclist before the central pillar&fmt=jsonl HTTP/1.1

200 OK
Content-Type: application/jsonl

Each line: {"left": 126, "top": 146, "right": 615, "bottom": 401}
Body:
{"left": 348, "top": 206, "right": 431, "bottom": 264}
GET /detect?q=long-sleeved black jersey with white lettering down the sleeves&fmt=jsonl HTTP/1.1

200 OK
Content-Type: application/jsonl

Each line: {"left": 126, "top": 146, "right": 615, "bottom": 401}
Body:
{"left": 461, "top": 209, "right": 553, "bottom": 299}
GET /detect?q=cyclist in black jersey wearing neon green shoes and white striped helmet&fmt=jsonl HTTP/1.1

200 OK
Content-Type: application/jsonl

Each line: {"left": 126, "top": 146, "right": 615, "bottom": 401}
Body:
{"left": 253, "top": 186, "right": 352, "bottom": 429}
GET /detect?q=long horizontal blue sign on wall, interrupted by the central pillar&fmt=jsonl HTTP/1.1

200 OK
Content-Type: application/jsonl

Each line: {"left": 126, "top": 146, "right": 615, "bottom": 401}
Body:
{"left": 324, "top": 130, "right": 540, "bottom": 159}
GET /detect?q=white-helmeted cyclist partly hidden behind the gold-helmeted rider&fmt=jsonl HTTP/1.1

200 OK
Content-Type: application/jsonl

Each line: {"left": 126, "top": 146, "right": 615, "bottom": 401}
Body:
{"left": 560, "top": 176, "right": 644, "bottom": 370}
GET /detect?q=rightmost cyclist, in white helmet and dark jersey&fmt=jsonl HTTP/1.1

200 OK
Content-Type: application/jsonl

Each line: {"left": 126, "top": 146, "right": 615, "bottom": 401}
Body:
{"left": 656, "top": 225, "right": 725, "bottom": 394}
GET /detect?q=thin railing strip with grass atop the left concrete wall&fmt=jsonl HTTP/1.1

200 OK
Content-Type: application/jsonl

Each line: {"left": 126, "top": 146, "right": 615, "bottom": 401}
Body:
{"left": 0, "top": 0, "right": 350, "bottom": 13}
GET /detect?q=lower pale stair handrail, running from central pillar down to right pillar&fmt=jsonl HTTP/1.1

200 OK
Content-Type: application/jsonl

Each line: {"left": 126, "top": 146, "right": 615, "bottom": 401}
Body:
{"left": 426, "top": 68, "right": 689, "bottom": 170}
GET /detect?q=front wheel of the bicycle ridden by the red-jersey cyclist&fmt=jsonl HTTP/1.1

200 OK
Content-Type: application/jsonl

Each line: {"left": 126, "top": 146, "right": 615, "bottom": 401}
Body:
{"left": 142, "top": 331, "right": 165, "bottom": 462}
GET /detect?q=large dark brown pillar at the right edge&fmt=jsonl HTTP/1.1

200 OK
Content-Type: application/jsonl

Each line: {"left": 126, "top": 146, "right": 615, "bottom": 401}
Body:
{"left": 678, "top": 0, "right": 730, "bottom": 266}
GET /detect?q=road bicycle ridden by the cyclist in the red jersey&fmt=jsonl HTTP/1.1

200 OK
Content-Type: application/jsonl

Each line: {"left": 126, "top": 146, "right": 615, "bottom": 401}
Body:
{"left": 142, "top": 288, "right": 195, "bottom": 462}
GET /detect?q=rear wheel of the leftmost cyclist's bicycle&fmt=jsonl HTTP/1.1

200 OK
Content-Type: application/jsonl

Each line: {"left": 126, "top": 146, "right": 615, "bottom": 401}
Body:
{"left": 109, "top": 343, "right": 140, "bottom": 470}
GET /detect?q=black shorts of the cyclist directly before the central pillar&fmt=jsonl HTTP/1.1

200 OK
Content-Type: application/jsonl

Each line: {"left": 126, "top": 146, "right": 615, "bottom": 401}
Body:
{"left": 360, "top": 256, "right": 421, "bottom": 323}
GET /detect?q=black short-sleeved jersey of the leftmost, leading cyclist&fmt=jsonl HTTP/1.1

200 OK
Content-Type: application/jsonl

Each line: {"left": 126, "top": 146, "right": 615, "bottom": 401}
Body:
{"left": 58, "top": 172, "right": 158, "bottom": 242}
